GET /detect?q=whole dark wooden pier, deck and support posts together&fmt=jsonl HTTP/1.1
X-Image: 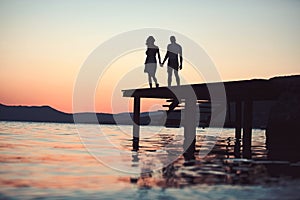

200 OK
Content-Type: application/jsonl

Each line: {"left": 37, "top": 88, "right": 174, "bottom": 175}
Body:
{"left": 123, "top": 79, "right": 283, "bottom": 158}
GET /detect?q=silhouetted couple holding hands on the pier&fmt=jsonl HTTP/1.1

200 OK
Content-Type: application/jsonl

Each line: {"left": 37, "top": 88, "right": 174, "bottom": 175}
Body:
{"left": 144, "top": 36, "right": 182, "bottom": 88}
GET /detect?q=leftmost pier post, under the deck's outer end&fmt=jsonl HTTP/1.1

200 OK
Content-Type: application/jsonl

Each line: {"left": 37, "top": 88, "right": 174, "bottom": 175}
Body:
{"left": 132, "top": 97, "right": 141, "bottom": 151}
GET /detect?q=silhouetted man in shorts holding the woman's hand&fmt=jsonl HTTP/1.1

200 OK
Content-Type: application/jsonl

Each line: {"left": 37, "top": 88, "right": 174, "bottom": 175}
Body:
{"left": 162, "top": 36, "right": 182, "bottom": 86}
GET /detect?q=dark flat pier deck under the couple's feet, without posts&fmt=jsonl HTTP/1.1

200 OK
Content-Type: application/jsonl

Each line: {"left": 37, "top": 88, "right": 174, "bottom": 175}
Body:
{"left": 123, "top": 79, "right": 282, "bottom": 101}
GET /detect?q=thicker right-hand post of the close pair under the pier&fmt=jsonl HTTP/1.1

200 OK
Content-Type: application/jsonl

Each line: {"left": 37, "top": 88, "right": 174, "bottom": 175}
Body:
{"left": 243, "top": 100, "right": 253, "bottom": 158}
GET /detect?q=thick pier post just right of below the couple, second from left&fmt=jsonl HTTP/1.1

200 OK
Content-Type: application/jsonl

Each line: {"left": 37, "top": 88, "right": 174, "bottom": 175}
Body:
{"left": 183, "top": 97, "right": 197, "bottom": 153}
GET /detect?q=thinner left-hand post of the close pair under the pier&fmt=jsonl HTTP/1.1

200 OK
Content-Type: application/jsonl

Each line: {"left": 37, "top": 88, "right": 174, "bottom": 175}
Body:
{"left": 234, "top": 100, "right": 242, "bottom": 158}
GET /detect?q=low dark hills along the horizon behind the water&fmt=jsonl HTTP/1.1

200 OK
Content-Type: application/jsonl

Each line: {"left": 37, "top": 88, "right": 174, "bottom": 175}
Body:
{"left": 0, "top": 104, "right": 266, "bottom": 129}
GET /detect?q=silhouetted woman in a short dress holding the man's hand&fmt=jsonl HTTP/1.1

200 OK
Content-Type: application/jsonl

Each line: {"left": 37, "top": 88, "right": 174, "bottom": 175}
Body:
{"left": 144, "top": 36, "right": 161, "bottom": 88}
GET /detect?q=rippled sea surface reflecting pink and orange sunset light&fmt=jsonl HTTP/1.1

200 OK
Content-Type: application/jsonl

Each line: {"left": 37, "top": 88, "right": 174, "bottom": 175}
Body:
{"left": 0, "top": 122, "right": 300, "bottom": 199}
